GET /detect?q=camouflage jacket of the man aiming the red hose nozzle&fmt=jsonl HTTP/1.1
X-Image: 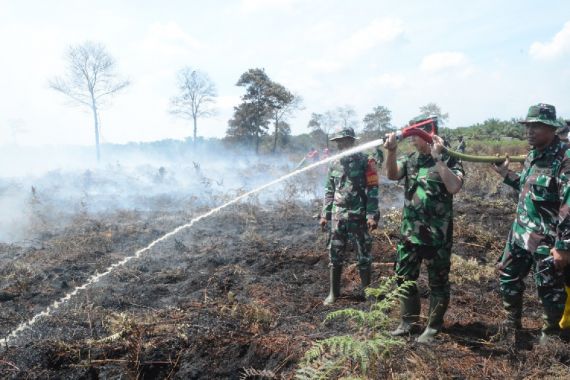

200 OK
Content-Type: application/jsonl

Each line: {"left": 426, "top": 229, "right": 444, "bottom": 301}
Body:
{"left": 398, "top": 152, "right": 464, "bottom": 247}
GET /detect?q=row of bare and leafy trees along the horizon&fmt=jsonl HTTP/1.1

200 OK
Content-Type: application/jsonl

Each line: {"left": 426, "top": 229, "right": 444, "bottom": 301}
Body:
{"left": 49, "top": 41, "right": 525, "bottom": 160}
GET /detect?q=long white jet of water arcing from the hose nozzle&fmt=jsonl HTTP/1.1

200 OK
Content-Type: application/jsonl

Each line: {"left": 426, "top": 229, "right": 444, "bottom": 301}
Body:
{"left": 0, "top": 139, "right": 384, "bottom": 346}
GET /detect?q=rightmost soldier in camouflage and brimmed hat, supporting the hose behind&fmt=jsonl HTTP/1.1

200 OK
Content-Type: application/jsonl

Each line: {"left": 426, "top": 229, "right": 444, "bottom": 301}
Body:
{"left": 493, "top": 104, "right": 570, "bottom": 344}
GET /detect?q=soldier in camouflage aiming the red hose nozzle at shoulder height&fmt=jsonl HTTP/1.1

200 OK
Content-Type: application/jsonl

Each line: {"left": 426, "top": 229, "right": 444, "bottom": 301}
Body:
{"left": 384, "top": 117, "right": 464, "bottom": 343}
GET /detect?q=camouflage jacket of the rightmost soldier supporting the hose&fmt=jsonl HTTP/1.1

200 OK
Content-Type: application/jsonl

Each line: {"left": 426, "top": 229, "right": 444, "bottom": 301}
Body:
{"left": 504, "top": 137, "right": 570, "bottom": 254}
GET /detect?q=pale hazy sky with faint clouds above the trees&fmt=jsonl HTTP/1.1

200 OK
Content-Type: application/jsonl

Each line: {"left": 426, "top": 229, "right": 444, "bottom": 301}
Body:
{"left": 0, "top": 0, "right": 570, "bottom": 145}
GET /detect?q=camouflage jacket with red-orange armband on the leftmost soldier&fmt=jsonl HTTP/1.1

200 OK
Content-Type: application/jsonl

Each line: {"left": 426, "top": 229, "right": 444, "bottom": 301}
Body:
{"left": 321, "top": 153, "right": 380, "bottom": 220}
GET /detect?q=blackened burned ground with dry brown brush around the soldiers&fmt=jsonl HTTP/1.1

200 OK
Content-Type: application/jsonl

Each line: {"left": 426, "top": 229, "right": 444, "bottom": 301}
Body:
{"left": 0, "top": 162, "right": 570, "bottom": 379}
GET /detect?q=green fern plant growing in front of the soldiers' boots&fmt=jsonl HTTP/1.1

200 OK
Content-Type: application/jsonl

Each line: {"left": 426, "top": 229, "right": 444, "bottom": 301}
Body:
{"left": 295, "top": 276, "right": 414, "bottom": 379}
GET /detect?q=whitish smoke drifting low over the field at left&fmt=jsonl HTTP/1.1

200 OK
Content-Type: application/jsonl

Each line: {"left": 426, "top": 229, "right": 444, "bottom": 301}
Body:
{"left": 0, "top": 141, "right": 306, "bottom": 243}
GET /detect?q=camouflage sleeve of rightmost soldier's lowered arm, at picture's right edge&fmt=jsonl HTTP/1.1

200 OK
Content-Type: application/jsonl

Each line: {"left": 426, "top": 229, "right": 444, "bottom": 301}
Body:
{"left": 554, "top": 154, "right": 570, "bottom": 251}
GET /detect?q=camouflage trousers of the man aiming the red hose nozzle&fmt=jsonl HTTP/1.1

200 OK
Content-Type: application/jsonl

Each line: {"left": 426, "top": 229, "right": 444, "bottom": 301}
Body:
{"left": 396, "top": 242, "right": 451, "bottom": 299}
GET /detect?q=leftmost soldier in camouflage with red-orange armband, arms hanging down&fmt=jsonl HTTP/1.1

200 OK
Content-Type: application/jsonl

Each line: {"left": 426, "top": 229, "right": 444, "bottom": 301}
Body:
{"left": 320, "top": 128, "right": 380, "bottom": 305}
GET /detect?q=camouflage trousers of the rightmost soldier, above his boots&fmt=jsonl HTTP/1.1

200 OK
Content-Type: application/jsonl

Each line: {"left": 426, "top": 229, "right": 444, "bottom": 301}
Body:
{"left": 497, "top": 242, "right": 566, "bottom": 313}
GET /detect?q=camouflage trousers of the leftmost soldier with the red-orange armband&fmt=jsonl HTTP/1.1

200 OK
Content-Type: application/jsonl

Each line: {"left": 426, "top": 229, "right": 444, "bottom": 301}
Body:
{"left": 328, "top": 219, "right": 372, "bottom": 268}
